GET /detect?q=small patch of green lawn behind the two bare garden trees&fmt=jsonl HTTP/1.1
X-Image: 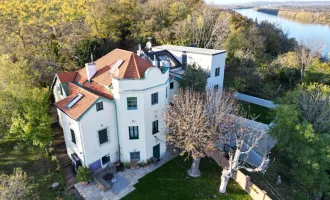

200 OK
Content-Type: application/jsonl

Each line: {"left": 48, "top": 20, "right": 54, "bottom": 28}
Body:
{"left": 239, "top": 101, "right": 275, "bottom": 124}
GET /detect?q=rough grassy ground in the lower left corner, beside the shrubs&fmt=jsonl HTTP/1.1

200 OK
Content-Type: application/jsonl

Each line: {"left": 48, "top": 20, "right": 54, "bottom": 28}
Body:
{"left": 0, "top": 140, "right": 64, "bottom": 200}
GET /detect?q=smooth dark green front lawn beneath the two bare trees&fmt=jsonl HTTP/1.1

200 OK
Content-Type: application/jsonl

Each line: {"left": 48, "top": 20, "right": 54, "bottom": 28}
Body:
{"left": 124, "top": 156, "right": 250, "bottom": 200}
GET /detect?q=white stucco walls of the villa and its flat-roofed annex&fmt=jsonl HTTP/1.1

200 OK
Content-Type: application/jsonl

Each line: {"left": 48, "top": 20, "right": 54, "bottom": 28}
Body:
{"left": 52, "top": 46, "right": 226, "bottom": 168}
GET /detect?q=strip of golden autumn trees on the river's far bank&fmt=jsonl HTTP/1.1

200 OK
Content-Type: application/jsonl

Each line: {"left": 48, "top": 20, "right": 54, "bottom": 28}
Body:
{"left": 253, "top": 7, "right": 330, "bottom": 26}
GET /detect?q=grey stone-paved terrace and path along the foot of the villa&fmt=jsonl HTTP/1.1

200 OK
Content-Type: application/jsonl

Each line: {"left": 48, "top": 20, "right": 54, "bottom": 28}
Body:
{"left": 74, "top": 152, "right": 177, "bottom": 200}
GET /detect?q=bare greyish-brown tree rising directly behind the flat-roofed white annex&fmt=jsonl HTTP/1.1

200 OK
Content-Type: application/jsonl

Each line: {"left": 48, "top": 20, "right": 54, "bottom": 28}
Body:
{"left": 164, "top": 5, "right": 230, "bottom": 49}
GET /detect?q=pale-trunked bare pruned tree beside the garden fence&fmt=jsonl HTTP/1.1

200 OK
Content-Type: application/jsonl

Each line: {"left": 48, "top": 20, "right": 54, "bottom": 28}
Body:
{"left": 219, "top": 117, "right": 270, "bottom": 194}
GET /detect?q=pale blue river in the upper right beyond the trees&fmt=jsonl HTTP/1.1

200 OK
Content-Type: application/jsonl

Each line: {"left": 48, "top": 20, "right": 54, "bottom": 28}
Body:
{"left": 235, "top": 8, "right": 330, "bottom": 58}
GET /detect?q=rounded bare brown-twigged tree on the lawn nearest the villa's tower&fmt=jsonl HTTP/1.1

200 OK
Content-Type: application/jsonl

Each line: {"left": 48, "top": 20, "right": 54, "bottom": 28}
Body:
{"left": 164, "top": 90, "right": 238, "bottom": 177}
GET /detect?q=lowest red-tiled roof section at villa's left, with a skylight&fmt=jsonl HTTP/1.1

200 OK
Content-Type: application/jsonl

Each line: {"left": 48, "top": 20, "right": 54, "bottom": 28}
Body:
{"left": 55, "top": 83, "right": 99, "bottom": 120}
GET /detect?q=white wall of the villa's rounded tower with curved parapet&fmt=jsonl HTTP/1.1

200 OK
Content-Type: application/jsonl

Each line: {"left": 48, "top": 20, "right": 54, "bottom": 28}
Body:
{"left": 112, "top": 67, "right": 169, "bottom": 161}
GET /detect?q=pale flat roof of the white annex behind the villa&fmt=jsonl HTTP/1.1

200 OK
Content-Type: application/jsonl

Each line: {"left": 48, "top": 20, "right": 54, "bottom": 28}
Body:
{"left": 152, "top": 45, "right": 226, "bottom": 55}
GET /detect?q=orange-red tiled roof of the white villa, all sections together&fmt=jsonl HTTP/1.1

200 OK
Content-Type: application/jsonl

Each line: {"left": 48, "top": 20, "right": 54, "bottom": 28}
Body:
{"left": 55, "top": 49, "right": 153, "bottom": 120}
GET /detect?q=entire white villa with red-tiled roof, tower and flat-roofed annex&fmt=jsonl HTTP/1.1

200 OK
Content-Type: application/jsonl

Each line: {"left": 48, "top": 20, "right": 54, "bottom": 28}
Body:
{"left": 52, "top": 45, "right": 226, "bottom": 170}
